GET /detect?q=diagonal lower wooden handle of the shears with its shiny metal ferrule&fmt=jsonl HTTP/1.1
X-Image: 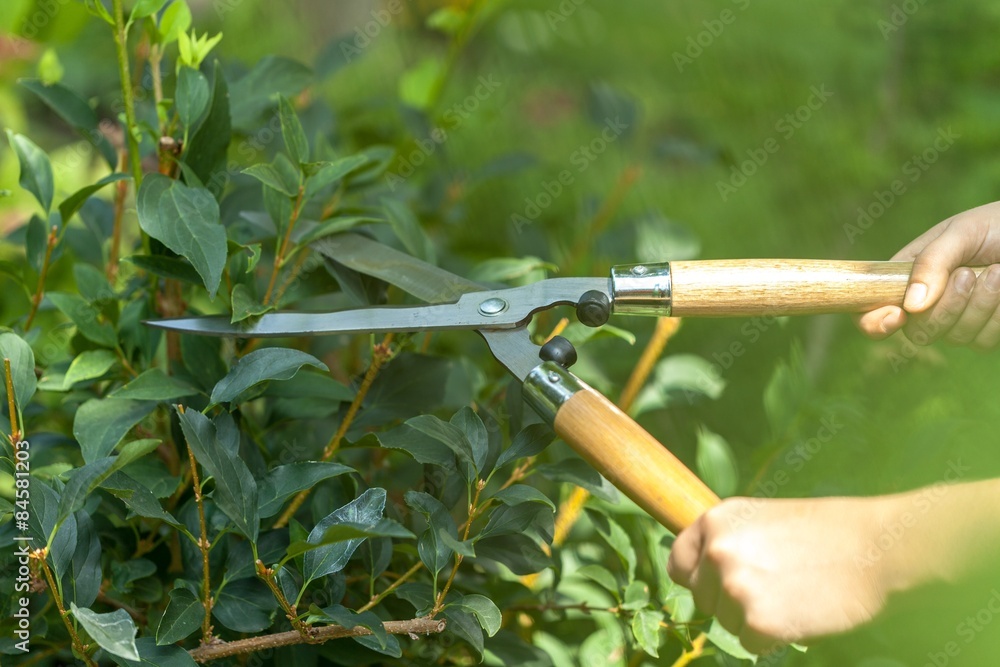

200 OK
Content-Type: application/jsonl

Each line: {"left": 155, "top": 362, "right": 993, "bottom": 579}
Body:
{"left": 524, "top": 362, "right": 719, "bottom": 533}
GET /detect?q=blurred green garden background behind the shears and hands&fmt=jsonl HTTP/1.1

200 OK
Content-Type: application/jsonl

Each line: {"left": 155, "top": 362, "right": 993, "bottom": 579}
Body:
{"left": 0, "top": 0, "right": 1000, "bottom": 667}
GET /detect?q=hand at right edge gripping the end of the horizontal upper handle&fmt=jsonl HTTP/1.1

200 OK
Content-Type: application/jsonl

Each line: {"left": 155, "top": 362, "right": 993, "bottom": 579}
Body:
{"left": 857, "top": 202, "right": 1000, "bottom": 350}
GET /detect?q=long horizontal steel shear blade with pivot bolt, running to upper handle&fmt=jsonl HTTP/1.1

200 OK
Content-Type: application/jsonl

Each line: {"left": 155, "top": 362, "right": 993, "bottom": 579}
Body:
{"left": 147, "top": 278, "right": 611, "bottom": 338}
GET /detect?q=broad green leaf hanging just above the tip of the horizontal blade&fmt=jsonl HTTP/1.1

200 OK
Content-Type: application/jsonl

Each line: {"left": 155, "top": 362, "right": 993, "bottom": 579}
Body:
{"left": 138, "top": 175, "right": 226, "bottom": 299}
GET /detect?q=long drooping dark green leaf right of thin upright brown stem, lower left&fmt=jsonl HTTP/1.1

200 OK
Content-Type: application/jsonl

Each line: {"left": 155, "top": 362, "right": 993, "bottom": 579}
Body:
{"left": 178, "top": 410, "right": 260, "bottom": 542}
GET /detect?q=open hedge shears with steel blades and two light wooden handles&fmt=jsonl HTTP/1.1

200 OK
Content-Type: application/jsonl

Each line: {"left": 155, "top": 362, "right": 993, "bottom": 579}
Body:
{"left": 147, "top": 234, "right": 944, "bottom": 533}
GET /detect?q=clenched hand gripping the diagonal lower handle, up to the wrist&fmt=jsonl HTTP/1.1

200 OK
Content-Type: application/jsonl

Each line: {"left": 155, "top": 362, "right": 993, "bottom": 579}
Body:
{"left": 668, "top": 498, "right": 898, "bottom": 653}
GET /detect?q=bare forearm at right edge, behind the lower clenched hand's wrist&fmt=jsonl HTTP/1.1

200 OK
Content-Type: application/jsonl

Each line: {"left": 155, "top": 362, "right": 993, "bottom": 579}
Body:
{"left": 880, "top": 478, "right": 1000, "bottom": 591}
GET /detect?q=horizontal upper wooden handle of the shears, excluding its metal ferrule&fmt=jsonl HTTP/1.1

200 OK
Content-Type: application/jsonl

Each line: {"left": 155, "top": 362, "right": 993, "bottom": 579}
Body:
{"left": 670, "top": 259, "right": 983, "bottom": 317}
